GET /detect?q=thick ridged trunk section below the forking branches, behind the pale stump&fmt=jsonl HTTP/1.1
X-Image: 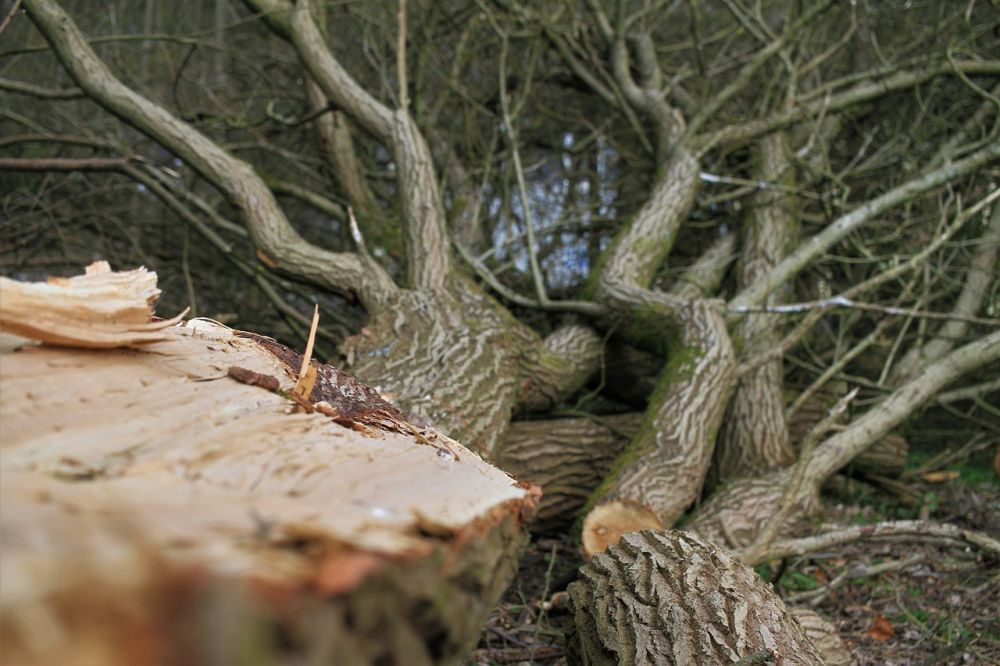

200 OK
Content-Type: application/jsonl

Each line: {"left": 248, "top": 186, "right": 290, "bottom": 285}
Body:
{"left": 344, "top": 278, "right": 540, "bottom": 454}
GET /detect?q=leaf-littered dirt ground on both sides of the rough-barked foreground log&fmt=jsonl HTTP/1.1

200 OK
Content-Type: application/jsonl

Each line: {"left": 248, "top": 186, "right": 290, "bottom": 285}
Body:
{"left": 468, "top": 470, "right": 1000, "bottom": 666}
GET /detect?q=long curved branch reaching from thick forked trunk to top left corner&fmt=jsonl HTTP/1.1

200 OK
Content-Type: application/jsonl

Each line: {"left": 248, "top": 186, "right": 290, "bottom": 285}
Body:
{"left": 24, "top": 0, "right": 396, "bottom": 308}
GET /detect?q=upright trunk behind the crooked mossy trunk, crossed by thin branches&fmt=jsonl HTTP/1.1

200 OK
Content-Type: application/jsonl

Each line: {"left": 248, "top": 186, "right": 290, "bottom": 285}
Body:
{"left": 715, "top": 132, "right": 795, "bottom": 480}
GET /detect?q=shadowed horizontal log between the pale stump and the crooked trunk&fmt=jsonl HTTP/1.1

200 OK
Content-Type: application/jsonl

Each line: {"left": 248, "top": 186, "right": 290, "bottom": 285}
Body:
{"left": 496, "top": 414, "right": 642, "bottom": 531}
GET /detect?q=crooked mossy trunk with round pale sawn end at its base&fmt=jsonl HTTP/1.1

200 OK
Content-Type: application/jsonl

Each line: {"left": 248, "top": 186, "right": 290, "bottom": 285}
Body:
{"left": 583, "top": 135, "right": 748, "bottom": 555}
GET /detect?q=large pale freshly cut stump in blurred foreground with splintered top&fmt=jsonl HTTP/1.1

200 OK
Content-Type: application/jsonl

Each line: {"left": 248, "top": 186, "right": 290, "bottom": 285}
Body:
{"left": 0, "top": 264, "right": 539, "bottom": 665}
